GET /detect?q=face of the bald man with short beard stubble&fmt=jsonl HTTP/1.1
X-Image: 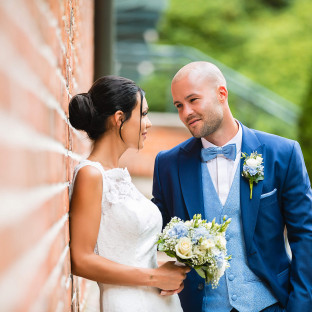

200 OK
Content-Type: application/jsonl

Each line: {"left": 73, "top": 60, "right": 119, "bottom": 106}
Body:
{"left": 171, "top": 76, "right": 223, "bottom": 138}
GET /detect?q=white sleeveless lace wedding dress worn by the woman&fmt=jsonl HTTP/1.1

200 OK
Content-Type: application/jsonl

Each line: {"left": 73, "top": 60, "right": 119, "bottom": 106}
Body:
{"left": 70, "top": 160, "right": 183, "bottom": 312}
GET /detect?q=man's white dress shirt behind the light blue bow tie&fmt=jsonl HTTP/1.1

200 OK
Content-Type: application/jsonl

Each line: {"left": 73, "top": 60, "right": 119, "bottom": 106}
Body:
{"left": 201, "top": 121, "right": 243, "bottom": 206}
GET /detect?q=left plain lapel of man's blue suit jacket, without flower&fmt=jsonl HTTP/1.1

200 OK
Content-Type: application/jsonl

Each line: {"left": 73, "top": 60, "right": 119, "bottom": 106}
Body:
{"left": 178, "top": 138, "right": 204, "bottom": 219}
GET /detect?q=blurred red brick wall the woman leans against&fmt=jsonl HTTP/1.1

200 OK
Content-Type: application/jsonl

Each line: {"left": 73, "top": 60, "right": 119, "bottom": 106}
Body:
{"left": 0, "top": 0, "right": 94, "bottom": 312}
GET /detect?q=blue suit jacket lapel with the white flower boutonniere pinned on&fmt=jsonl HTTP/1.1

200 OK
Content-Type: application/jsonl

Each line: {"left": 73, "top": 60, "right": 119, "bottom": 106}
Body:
{"left": 240, "top": 125, "right": 265, "bottom": 255}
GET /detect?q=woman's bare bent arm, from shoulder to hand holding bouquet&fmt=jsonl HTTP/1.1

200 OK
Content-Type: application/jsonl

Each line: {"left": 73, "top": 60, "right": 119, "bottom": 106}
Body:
{"left": 70, "top": 166, "right": 189, "bottom": 290}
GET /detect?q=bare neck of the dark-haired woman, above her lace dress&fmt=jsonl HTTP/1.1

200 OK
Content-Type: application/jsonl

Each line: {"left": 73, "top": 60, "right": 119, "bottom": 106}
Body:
{"left": 88, "top": 133, "right": 126, "bottom": 169}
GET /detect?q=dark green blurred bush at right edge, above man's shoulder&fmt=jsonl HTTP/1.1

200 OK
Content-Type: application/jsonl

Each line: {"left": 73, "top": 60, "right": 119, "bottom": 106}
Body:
{"left": 299, "top": 73, "right": 312, "bottom": 179}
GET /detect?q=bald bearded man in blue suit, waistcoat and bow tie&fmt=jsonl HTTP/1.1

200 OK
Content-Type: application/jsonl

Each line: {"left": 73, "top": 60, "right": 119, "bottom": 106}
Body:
{"left": 153, "top": 62, "right": 312, "bottom": 312}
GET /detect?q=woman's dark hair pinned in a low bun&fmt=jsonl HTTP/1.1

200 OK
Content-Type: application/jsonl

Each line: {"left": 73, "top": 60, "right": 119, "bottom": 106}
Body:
{"left": 69, "top": 76, "right": 144, "bottom": 141}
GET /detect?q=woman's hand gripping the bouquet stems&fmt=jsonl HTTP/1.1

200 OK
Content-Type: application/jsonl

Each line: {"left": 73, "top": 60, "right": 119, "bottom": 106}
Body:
{"left": 151, "top": 261, "right": 191, "bottom": 291}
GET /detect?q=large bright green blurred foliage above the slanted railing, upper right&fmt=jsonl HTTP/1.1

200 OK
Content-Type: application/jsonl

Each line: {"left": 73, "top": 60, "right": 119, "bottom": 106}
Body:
{"left": 159, "top": 0, "right": 312, "bottom": 105}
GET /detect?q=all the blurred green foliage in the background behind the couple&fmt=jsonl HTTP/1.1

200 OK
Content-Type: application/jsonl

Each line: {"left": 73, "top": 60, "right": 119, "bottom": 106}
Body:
{"left": 143, "top": 0, "right": 312, "bottom": 176}
